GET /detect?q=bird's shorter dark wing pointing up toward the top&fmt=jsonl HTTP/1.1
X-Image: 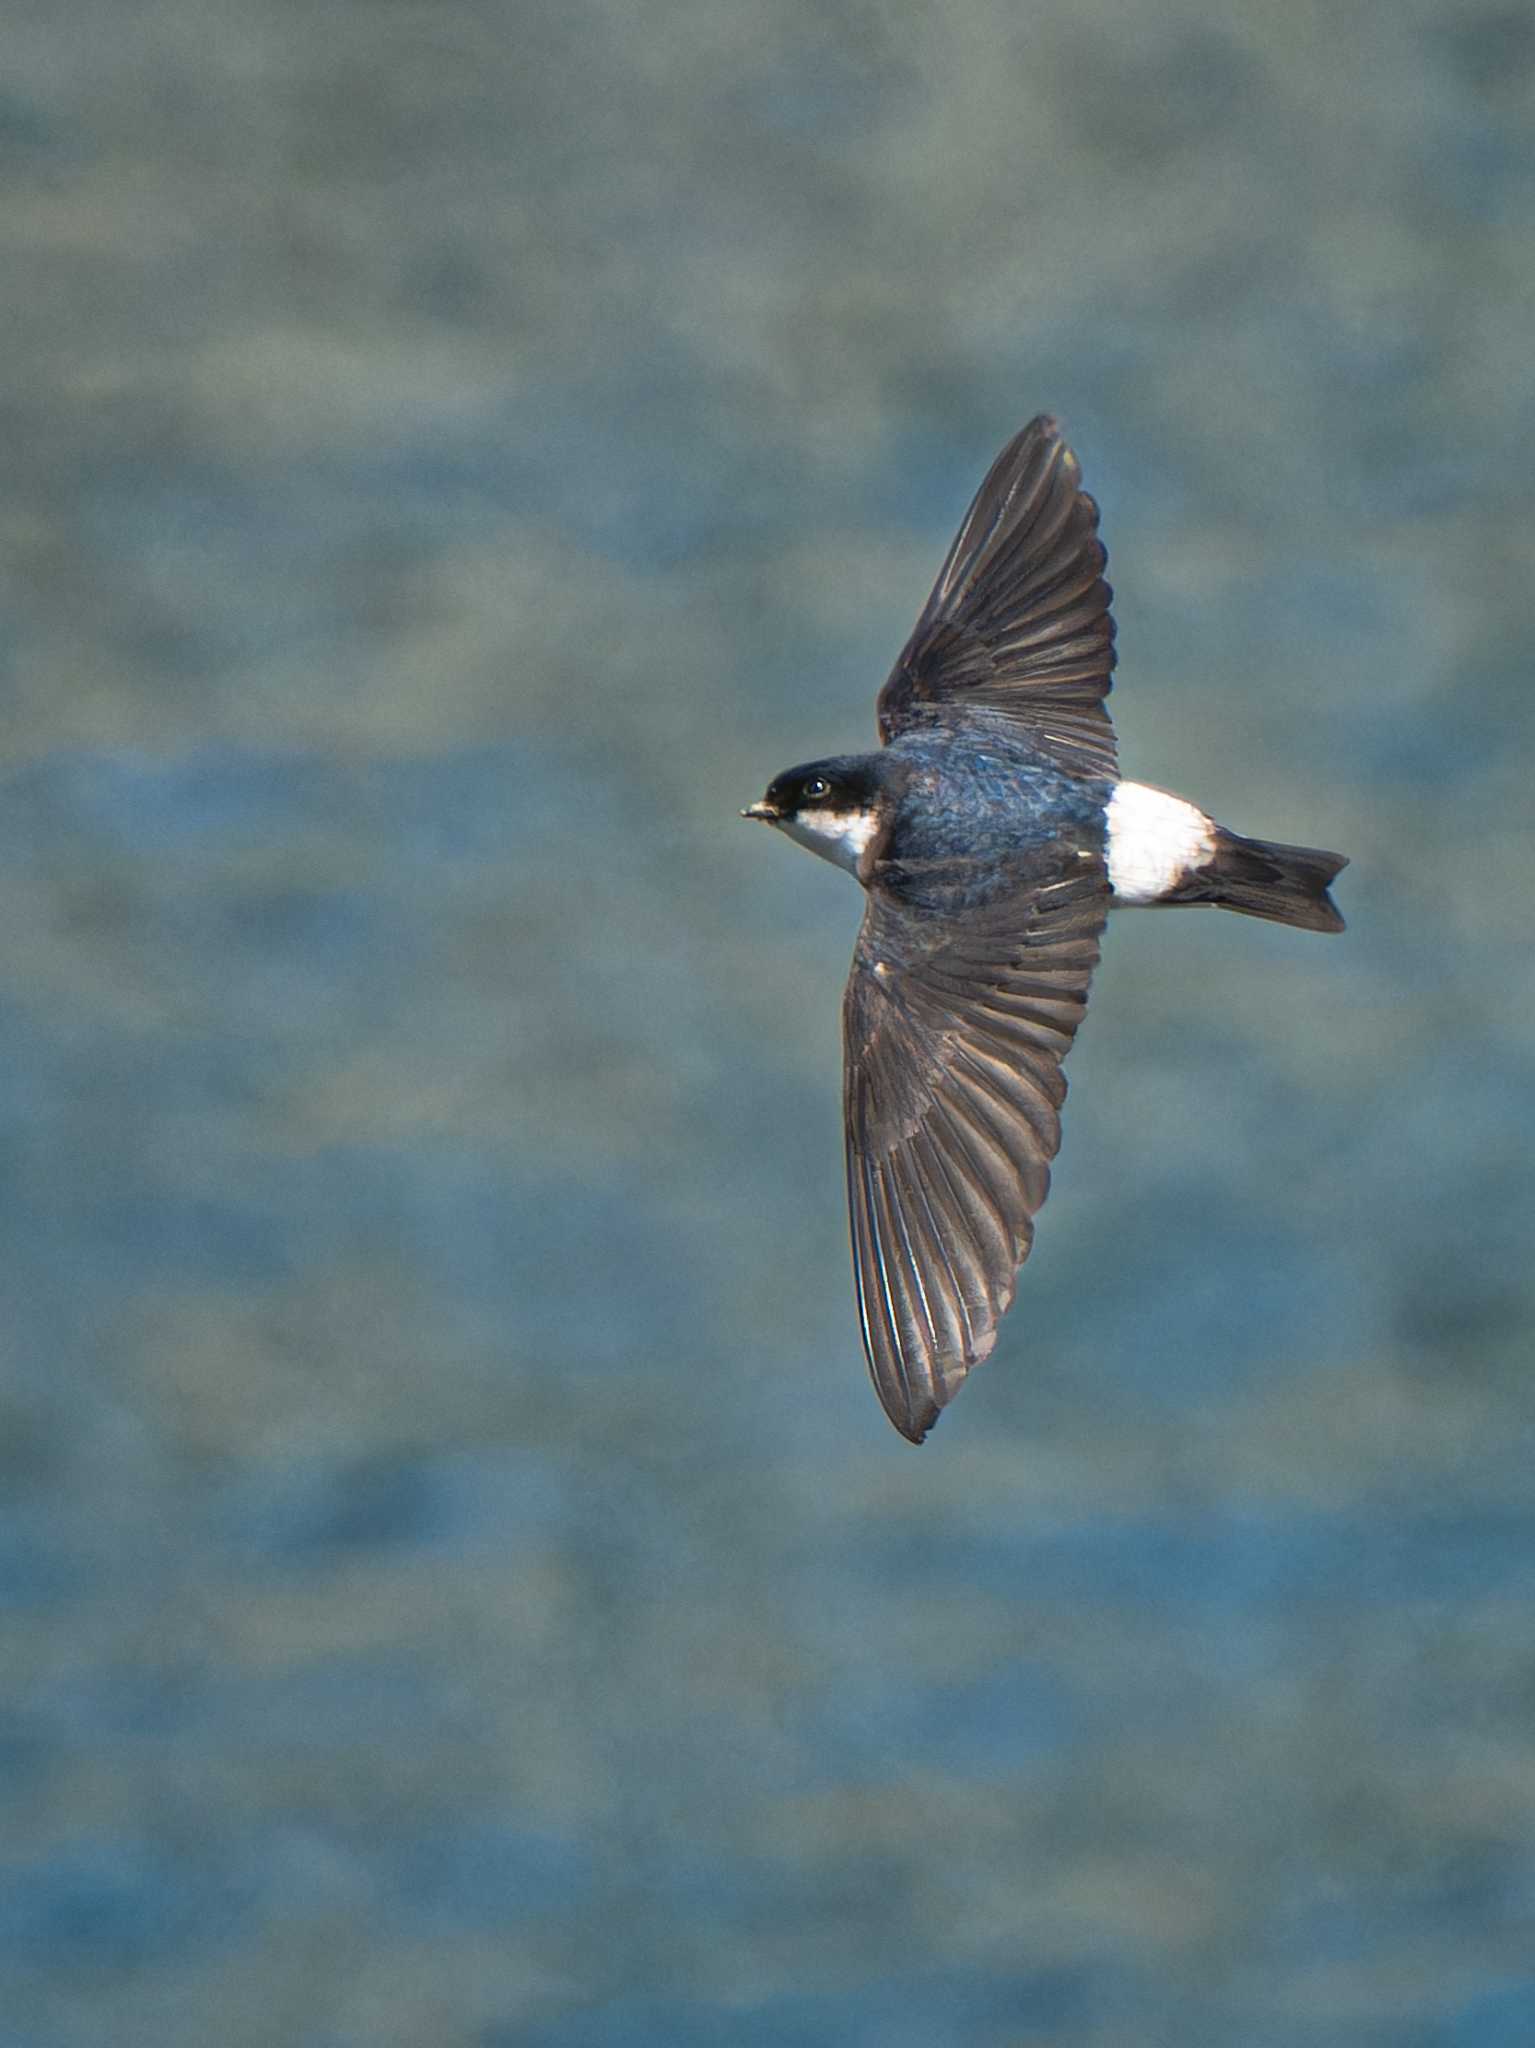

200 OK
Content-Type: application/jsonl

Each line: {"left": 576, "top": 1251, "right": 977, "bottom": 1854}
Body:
{"left": 878, "top": 414, "right": 1117, "bottom": 776}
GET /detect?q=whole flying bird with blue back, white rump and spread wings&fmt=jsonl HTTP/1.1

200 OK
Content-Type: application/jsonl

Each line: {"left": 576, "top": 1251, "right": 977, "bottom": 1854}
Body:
{"left": 741, "top": 414, "right": 1347, "bottom": 1444}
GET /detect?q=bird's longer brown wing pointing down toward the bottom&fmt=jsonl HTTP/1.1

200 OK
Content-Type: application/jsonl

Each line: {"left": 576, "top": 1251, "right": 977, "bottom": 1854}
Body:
{"left": 843, "top": 850, "right": 1109, "bottom": 1444}
